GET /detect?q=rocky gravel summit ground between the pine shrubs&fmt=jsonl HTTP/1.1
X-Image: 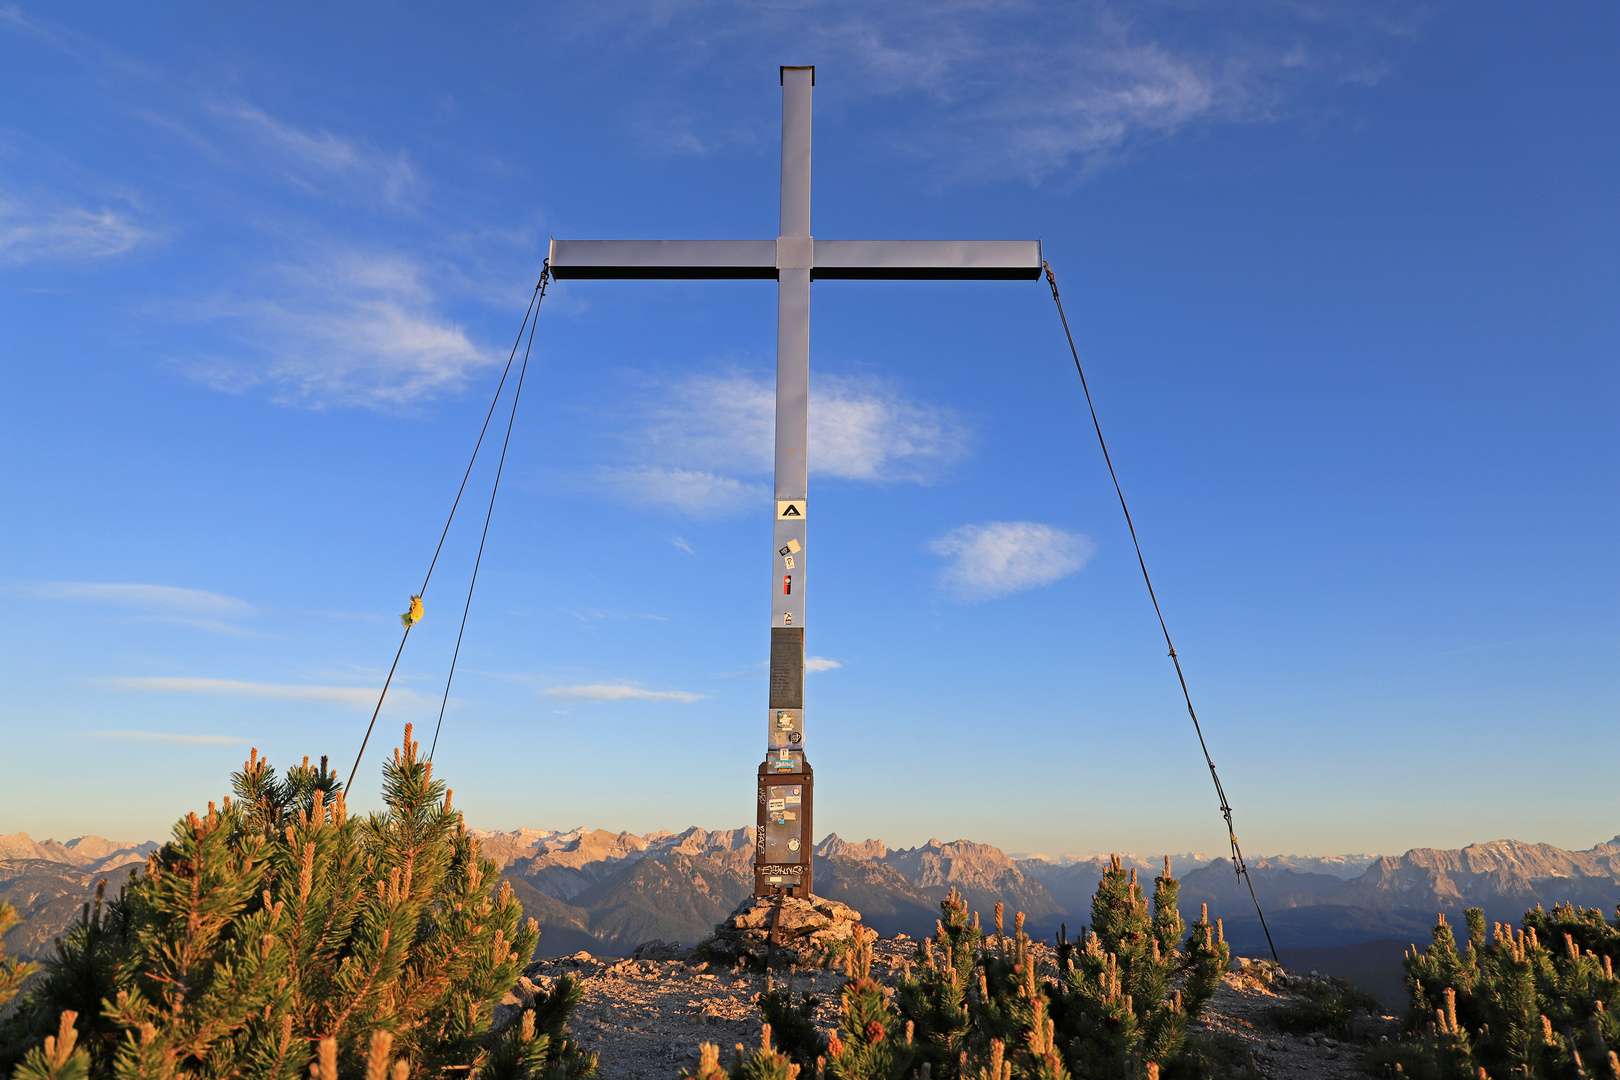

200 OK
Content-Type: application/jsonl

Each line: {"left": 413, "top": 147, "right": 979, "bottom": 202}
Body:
{"left": 504, "top": 934, "right": 1396, "bottom": 1080}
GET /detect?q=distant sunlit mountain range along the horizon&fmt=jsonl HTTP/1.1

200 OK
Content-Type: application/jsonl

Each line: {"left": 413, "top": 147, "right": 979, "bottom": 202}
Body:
{"left": 0, "top": 827, "right": 1620, "bottom": 977}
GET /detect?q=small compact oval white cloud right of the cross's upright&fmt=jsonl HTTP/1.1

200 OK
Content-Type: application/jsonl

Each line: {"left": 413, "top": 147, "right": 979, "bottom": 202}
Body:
{"left": 928, "top": 521, "right": 1097, "bottom": 601}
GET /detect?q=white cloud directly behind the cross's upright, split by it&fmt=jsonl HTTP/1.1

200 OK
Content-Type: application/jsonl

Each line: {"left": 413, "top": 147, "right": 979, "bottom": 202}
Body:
{"left": 590, "top": 371, "right": 972, "bottom": 517}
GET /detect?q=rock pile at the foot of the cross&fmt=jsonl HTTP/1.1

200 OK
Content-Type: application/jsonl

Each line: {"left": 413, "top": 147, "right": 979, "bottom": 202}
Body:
{"left": 703, "top": 895, "right": 878, "bottom": 967}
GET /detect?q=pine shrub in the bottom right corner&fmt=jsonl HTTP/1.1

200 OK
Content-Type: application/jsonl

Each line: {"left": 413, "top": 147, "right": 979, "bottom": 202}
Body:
{"left": 1382, "top": 904, "right": 1620, "bottom": 1080}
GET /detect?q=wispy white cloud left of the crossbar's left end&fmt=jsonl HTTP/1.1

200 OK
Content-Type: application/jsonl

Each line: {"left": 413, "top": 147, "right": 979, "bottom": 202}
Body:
{"left": 170, "top": 251, "right": 499, "bottom": 408}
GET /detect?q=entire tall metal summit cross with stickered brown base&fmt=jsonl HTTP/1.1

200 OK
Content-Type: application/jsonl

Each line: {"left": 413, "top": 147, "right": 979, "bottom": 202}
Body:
{"left": 551, "top": 66, "right": 1040, "bottom": 895}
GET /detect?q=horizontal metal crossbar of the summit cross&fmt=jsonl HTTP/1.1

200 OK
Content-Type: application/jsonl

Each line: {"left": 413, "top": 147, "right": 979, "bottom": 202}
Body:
{"left": 551, "top": 240, "right": 1040, "bottom": 280}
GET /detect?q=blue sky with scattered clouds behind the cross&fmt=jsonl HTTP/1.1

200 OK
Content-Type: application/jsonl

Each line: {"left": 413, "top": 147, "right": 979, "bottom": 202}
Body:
{"left": 0, "top": 0, "right": 1620, "bottom": 853}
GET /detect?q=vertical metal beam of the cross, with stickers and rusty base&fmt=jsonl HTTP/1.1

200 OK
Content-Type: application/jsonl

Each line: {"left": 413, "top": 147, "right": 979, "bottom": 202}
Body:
{"left": 753, "top": 68, "right": 815, "bottom": 895}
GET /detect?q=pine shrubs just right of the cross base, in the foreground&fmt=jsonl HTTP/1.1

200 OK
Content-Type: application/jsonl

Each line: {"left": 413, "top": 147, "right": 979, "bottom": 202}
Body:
{"left": 741, "top": 858, "right": 1231, "bottom": 1080}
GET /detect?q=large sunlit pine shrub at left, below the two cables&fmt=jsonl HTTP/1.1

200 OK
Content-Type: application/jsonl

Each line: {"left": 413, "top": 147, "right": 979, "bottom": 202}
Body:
{"left": 0, "top": 725, "right": 596, "bottom": 1080}
